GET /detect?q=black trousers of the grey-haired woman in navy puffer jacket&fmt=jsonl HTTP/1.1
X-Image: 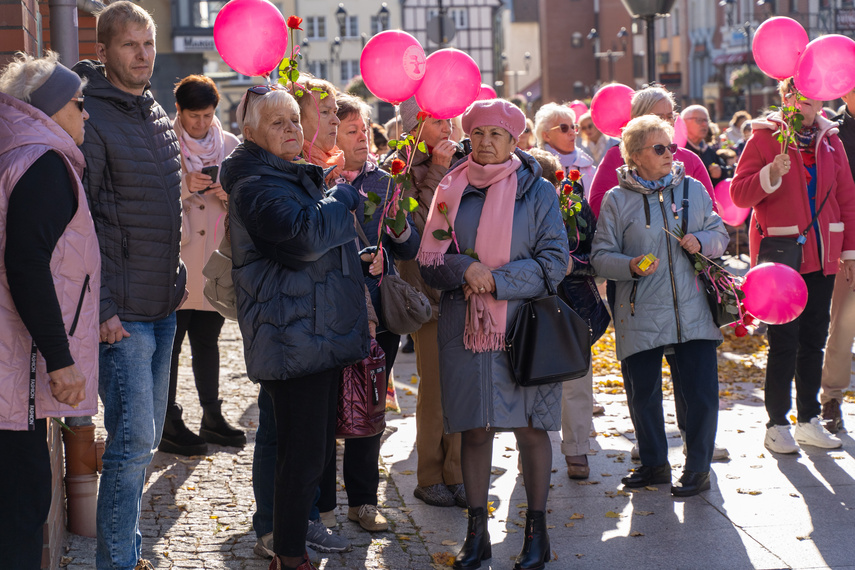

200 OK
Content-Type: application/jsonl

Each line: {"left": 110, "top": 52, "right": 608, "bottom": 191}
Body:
{"left": 261, "top": 368, "right": 341, "bottom": 556}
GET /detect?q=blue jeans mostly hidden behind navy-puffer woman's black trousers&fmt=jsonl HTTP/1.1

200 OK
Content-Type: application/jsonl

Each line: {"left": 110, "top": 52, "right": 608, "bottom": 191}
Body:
{"left": 252, "top": 386, "right": 321, "bottom": 538}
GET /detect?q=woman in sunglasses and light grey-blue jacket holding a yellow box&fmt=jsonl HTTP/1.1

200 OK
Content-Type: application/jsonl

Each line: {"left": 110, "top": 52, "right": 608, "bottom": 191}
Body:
{"left": 591, "top": 115, "right": 728, "bottom": 496}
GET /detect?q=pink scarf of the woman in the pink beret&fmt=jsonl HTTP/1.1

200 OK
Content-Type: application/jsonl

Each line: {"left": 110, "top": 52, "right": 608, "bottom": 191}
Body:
{"left": 418, "top": 155, "right": 522, "bottom": 352}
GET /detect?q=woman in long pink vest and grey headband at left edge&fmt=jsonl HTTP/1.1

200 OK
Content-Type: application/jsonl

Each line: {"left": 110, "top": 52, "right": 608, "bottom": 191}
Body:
{"left": 0, "top": 52, "right": 101, "bottom": 570}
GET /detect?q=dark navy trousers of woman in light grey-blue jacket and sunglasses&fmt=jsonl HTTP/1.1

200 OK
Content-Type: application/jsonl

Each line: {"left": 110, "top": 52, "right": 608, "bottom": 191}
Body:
{"left": 622, "top": 340, "right": 718, "bottom": 471}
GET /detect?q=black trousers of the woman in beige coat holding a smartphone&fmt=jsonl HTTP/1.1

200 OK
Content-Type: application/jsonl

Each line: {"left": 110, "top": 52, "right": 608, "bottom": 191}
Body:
{"left": 166, "top": 309, "right": 226, "bottom": 410}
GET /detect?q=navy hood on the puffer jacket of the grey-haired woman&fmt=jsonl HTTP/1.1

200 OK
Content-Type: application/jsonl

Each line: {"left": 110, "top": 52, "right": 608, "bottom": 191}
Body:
{"left": 220, "top": 141, "right": 324, "bottom": 194}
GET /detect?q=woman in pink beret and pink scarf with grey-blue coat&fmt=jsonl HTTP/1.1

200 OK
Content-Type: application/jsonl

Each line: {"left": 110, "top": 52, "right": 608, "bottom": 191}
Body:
{"left": 418, "top": 99, "right": 569, "bottom": 570}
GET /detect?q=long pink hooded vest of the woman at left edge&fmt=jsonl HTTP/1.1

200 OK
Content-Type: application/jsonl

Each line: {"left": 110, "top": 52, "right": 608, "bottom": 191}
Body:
{"left": 0, "top": 93, "right": 101, "bottom": 431}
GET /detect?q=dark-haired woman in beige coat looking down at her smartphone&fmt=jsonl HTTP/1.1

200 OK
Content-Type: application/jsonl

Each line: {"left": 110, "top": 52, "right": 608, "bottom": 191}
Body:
{"left": 158, "top": 75, "right": 246, "bottom": 455}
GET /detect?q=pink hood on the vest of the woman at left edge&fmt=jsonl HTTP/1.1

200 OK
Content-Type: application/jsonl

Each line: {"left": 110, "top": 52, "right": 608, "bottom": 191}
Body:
{"left": 0, "top": 93, "right": 86, "bottom": 176}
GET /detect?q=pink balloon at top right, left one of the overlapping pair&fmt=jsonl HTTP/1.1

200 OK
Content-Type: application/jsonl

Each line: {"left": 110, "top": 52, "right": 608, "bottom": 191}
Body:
{"left": 751, "top": 16, "right": 808, "bottom": 79}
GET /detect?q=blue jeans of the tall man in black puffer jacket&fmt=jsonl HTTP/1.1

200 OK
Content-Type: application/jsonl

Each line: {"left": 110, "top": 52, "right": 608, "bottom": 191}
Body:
{"left": 95, "top": 313, "right": 175, "bottom": 569}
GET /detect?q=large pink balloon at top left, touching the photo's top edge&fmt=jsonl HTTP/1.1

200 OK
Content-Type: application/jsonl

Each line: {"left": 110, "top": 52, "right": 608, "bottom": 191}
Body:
{"left": 214, "top": 0, "right": 288, "bottom": 76}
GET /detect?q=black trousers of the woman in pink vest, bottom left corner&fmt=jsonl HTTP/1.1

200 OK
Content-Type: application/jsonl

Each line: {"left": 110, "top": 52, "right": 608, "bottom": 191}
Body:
{"left": 0, "top": 420, "right": 51, "bottom": 570}
